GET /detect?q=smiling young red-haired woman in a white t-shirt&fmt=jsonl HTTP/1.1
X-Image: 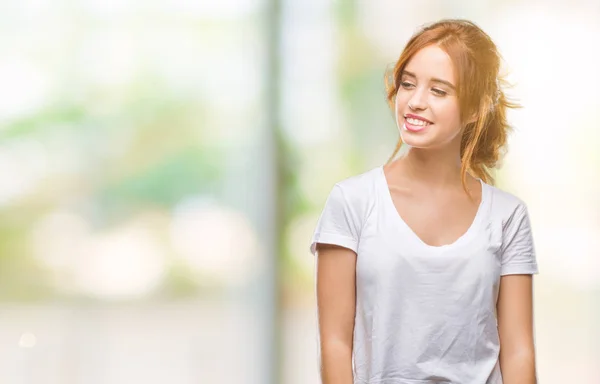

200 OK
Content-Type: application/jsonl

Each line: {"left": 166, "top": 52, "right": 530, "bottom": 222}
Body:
{"left": 311, "top": 20, "right": 538, "bottom": 384}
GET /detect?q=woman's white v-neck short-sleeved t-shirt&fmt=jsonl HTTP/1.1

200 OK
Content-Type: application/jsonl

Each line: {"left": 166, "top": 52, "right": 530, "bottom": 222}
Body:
{"left": 310, "top": 166, "right": 538, "bottom": 384}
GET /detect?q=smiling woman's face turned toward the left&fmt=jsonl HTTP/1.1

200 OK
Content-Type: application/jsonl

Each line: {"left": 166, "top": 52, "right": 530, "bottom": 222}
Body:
{"left": 395, "top": 45, "right": 462, "bottom": 148}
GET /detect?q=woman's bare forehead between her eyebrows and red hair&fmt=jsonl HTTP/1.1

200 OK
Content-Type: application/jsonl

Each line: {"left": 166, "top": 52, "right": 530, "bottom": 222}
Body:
{"left": 404, "top": 45, "right": 456, "bottom": 84}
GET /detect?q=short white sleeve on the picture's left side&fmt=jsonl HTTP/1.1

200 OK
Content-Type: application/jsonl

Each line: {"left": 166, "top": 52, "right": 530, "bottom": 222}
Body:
{"left": 310, "top": 184, "right": 361, "bottom": 255}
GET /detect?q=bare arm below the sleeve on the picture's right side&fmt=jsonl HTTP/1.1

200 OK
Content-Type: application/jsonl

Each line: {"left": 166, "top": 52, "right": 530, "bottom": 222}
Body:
{"left": 497, "top": 274, "right": 537, "bottom": 384}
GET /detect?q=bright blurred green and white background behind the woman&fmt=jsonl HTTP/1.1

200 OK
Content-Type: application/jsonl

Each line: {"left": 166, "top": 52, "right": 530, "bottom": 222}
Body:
{"left": 0, "top": 0, "right": 600, "bottom": 384}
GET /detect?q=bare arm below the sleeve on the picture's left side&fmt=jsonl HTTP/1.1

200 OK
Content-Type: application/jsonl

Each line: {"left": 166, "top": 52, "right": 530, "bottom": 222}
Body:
{"left": 317, "top": 243, "right": 356, "bottom": 384}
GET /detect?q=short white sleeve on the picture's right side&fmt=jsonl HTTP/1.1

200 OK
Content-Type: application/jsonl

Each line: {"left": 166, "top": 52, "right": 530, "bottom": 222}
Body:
{"left": 500, "top": 203, "right": 538, "bottom": 276}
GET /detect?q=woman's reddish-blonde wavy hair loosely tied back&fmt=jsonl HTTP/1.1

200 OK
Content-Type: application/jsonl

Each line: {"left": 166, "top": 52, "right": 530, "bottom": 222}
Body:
{"left": 385, "top": 19, "right": 520, "bottom": 196}
